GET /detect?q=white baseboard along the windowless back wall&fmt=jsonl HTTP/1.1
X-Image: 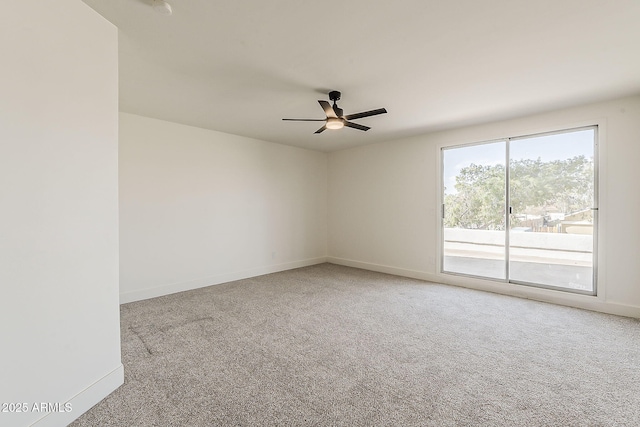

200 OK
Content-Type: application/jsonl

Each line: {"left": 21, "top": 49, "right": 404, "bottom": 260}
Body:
{"left": 120, "top": 257, "right": 327, "bottom": 304}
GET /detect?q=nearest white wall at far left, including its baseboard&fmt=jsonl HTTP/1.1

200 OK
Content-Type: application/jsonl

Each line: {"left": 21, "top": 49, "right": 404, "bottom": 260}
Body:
{"left": 0, "top": 0, "right": 123, "bottom": 426}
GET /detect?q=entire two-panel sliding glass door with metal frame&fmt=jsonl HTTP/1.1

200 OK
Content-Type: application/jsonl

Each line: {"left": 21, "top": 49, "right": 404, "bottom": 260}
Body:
{"left": 442, "top": 127, "right": 597, "bottom": 294}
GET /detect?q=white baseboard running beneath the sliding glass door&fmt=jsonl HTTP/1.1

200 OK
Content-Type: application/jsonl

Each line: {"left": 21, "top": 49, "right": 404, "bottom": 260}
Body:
{"left": 327, "top": 257, "right": 640, "bottom": 318}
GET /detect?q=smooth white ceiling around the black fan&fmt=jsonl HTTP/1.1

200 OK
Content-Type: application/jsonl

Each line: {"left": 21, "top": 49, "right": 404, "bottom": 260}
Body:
{"left": 84, "top": 0, "right": 640, "bottom": 151}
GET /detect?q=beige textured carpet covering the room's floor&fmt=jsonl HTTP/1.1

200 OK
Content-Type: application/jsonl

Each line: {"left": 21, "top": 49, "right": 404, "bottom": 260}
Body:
{"left": 73, "top": 264, "right": 640, "bottom": 427}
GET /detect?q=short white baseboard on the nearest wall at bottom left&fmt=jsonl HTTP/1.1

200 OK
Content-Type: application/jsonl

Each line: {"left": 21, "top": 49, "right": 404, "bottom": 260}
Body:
{"left": 32, "top": 365, "right": 124, "bottom": 427}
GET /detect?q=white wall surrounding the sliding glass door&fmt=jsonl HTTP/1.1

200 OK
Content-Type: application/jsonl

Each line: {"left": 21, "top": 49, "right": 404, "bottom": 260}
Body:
{"left": 328, "top": 96, "right": 640, "bottom": 317}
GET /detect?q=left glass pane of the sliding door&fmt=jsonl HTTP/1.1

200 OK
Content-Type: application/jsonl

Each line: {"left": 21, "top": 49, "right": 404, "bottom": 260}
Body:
{"left": 442, "top": 141, "right": 506, "bottom": 279}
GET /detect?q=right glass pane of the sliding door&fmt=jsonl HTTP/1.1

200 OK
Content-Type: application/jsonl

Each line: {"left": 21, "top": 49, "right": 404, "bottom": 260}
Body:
{"left": 509, "top": 129, "right": 595, "bottom": 292}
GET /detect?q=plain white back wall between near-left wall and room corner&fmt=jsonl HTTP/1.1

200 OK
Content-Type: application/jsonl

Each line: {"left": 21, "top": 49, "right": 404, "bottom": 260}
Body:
{"left": 120, "top": 113, "right": 327, "bottom": 302}
